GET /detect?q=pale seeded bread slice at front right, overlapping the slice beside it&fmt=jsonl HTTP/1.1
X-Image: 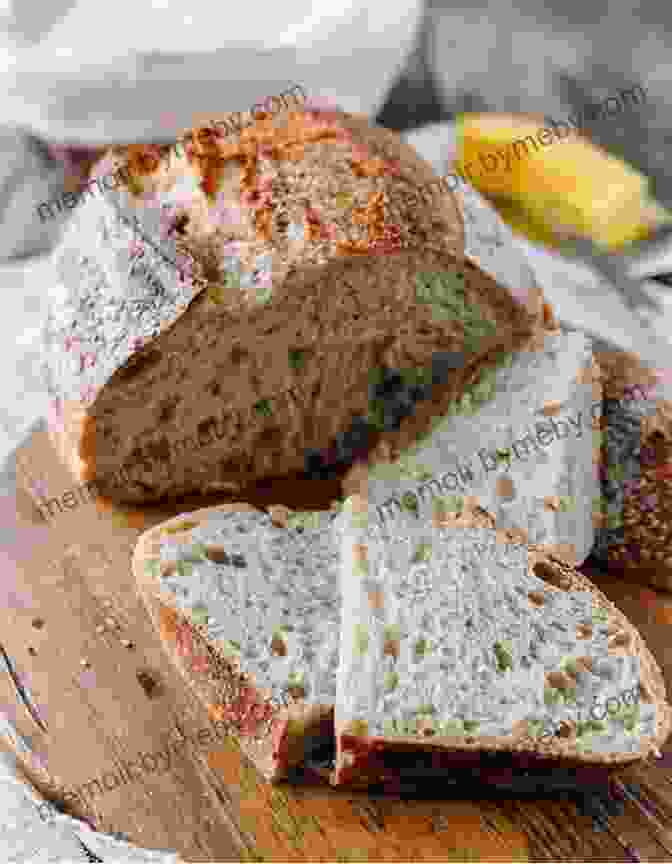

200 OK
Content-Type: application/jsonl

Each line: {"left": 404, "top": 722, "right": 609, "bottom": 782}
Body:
{"left": 332, "top": 496, "right": 672, "bottom": 784}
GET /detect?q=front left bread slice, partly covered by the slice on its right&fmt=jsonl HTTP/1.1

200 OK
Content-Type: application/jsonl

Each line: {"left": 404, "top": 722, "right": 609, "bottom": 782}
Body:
{"left": 133, "top": 503, "right": 340, "bottom": 780}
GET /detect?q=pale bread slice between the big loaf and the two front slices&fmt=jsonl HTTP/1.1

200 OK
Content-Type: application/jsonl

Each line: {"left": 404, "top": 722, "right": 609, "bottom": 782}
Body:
{"left": 344, "top": 329, "right": 602, "bottom": 564}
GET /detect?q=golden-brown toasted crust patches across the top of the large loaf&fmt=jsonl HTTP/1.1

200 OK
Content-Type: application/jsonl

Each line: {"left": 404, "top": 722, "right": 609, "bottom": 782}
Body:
{"left": 119, "top": 110, "right": 464, "bottom": 284}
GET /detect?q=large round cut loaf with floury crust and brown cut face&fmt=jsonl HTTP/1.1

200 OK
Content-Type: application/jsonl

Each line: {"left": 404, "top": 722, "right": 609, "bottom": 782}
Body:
{"left": 44, "top": 111, "right": 542, "bottom": 502}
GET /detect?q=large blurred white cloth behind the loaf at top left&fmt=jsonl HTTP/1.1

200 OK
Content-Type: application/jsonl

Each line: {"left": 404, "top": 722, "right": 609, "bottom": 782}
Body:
{"left": 0, "top": 0, "right": 421, "bottom": 144}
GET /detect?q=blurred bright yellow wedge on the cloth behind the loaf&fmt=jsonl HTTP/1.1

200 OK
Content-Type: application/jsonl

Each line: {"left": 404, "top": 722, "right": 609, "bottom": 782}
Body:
{"left": 456, "top": 114, "right": 672, "bottom": 250}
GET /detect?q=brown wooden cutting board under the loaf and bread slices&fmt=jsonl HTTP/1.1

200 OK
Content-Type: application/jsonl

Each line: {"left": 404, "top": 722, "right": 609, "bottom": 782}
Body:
{"left": 0, "top": 431, "right": 672, "bottom": 861}
